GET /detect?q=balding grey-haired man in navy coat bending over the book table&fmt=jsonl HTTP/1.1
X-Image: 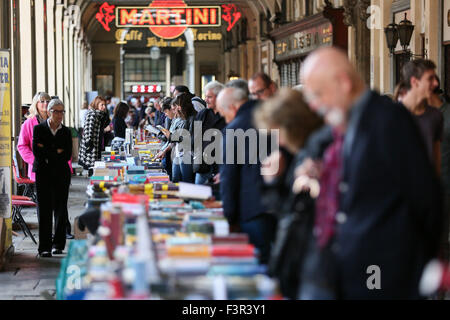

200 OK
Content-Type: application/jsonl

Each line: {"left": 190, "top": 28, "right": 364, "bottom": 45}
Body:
{"left": 217, "top": 88, "right": 275, "bottom": 263}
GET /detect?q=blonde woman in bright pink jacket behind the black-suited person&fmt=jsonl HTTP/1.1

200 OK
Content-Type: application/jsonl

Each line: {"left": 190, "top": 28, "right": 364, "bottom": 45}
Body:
{"left": 17, "top": 92, "right": 73, "bottom": 239}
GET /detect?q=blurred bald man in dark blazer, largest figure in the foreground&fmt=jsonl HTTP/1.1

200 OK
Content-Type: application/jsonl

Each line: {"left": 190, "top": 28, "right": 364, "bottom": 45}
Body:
{"left": 300, "top": 48, "right": 442, "bottom": 299}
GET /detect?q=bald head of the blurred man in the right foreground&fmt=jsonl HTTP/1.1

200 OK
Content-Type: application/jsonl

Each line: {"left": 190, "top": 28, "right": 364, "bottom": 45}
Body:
{"left": 300, "top": 47, "right": 365, "bottom": 128}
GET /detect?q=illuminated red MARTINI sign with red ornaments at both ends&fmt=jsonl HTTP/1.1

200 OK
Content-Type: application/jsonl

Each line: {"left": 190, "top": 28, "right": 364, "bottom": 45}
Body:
{"left": 96, "top": 0, "right": 242, "bottom": 39}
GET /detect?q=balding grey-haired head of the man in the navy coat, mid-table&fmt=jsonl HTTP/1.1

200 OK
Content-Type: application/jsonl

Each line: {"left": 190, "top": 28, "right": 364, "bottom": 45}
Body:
{"left": 216, "top": 87, "right": 248, "bottom": 123}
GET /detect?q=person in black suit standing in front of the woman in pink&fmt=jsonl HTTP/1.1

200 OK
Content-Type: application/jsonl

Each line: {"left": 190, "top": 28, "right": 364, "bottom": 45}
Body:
{"left": 33, "top": 99, "right": 72, "bottom": 257}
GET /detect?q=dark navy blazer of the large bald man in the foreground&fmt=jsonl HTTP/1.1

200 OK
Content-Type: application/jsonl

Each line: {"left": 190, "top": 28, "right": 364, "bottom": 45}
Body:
{"left": 331, "top": 92, "right": 442, "bottom": 299}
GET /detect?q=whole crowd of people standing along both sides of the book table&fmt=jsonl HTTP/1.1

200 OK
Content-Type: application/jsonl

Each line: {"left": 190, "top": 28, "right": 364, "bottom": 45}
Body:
{"left": 15, "top": 48, "right": 450, "bottom": 299}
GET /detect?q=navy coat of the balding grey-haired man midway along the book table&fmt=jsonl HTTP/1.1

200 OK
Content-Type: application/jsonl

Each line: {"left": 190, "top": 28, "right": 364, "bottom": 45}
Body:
{"left": 220, "top": 101, "right": 265, "bottom": 224}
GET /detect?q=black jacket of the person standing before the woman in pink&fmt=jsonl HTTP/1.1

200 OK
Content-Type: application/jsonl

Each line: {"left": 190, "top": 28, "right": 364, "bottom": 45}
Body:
{"left": 33, "top": 121, "right": 72, "bottom": 177}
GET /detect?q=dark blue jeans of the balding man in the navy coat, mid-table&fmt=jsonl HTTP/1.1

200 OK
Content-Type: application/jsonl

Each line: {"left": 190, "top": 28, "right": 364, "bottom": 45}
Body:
{"left": 240, "top": 214, "right": 276, "bottom": 264}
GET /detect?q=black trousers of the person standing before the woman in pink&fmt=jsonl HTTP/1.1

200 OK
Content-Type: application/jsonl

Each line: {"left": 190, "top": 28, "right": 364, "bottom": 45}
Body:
{"left": 36, "top": 170, "right": 70, "bottom": 253}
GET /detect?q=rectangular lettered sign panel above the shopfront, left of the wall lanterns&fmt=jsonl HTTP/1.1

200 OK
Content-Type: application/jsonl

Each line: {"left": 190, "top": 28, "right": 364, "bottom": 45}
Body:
{"left": 275, "top": 22, "right": 333, "bottom": 60}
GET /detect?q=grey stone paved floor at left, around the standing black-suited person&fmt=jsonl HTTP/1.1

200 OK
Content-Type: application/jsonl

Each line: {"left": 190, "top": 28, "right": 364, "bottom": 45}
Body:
{"left": 0, "top": 176, "right": 88, "bottom": 300}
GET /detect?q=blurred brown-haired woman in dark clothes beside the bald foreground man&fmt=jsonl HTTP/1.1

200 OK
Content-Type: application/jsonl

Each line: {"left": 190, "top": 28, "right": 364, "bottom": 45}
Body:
{"left": 254, "top": 89, "right": 323, "bottom": 299}
